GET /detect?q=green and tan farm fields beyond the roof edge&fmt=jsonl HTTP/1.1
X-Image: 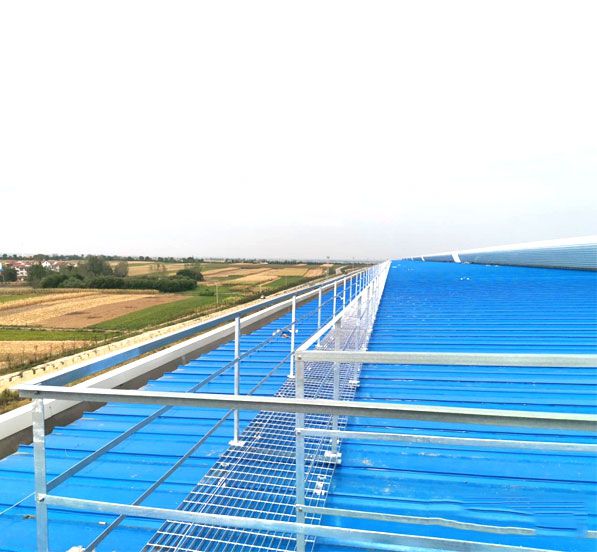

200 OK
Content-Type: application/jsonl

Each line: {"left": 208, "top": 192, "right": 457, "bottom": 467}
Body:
{"left": 0, "top": 261, "right": 338, "bottom": 382}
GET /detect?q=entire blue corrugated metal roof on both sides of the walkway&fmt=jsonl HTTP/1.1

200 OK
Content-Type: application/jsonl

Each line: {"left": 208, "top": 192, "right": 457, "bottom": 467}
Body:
{"left": 0, "top": 261, "right": 597, "bottom": 551}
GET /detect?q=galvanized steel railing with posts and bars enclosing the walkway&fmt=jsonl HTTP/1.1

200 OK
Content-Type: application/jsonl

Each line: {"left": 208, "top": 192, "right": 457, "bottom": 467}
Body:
{"left": 12, "top": 264, "right": 597, "bottom": 551}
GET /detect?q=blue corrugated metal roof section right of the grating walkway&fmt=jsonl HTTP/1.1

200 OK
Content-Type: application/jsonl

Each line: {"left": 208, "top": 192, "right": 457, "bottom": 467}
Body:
{"left": 324, "top": 261, "right": 597, "bottom": 551}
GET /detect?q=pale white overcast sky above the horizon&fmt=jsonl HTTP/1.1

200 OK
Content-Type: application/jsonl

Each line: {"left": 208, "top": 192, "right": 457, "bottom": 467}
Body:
{"left": 0, "top": 0, "right": 597, "bottom": 258}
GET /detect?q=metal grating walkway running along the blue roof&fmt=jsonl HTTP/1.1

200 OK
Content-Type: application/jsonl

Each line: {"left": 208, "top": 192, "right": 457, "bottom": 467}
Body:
{"left": 143, "top": 284, "right": 375, "bottom": 552}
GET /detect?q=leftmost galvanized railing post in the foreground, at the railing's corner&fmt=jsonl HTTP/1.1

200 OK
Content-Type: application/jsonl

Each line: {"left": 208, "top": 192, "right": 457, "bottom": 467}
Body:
{"left": 33, "top": 399, "right": 48, "bottom": 552}
